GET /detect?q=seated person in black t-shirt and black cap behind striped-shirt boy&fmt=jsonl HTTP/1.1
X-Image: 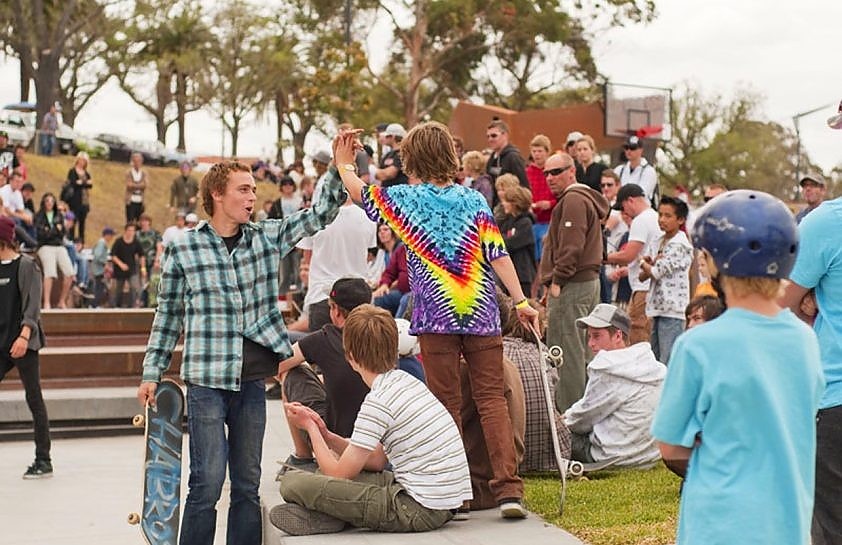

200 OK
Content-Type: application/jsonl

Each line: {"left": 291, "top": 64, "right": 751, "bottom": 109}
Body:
{"left": 278, "top": 278, "right": 371, "bottom": 472}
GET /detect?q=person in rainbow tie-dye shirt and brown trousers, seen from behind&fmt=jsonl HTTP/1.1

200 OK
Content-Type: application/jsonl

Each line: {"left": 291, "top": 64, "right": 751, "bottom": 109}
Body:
{"left": 334, "top": 122, "right": 538, "bottom": 518}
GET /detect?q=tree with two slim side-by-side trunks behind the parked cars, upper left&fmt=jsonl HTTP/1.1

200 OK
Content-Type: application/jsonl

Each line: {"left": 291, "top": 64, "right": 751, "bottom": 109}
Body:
{"left": 108, "top": 0, "right": 213, "bottom": 150}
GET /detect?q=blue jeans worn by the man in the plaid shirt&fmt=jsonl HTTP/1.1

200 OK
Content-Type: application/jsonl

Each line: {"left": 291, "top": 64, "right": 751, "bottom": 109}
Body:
{"left": 179, "top": 379, "right": 266, "bottom": 545}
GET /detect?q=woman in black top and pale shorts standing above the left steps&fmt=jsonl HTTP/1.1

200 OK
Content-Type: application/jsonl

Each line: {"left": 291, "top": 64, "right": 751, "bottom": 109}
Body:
{"left": 33, "top": 192, "right": 74, "bottom": 308}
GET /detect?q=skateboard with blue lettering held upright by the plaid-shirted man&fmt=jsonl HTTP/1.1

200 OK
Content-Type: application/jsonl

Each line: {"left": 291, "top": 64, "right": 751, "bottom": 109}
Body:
{"left": 129, "top": 380, "right": 184, "bottom": 545}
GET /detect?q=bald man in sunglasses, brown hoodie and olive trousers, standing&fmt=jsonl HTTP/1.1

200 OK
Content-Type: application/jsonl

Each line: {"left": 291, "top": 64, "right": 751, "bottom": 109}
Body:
{"left": 540, "top": 153, "right": 609, "bottom": 412}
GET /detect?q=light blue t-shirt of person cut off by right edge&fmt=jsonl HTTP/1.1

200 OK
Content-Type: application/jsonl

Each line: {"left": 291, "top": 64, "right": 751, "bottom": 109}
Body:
{"left": 790, "top": 197, "right": 842, "bottom": 409}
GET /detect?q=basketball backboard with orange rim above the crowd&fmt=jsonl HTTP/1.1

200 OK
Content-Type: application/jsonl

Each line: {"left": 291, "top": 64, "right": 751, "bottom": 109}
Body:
{"left": 603, "top": 82, "right": 672, "bottom": 141}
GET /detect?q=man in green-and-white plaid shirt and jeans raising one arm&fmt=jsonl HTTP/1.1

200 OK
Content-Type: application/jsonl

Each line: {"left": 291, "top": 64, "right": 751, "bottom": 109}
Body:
{"left": 138, "top": 161, "right": 347, "bottom": 545}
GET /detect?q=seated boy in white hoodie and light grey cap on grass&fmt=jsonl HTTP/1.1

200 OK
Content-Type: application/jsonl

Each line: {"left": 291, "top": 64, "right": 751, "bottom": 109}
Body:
{"left": 564, "top": 303, "right": 666, "bottom": 467}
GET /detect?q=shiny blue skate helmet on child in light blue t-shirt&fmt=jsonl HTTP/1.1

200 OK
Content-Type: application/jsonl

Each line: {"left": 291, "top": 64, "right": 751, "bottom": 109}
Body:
{"left": 692, "top": 189, "right": 798, "bottom": 278}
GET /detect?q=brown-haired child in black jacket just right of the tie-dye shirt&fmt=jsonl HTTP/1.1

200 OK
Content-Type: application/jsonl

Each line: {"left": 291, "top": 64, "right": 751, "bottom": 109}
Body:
{"left": 499, "top": 186, "right": 537, "bottom": 293}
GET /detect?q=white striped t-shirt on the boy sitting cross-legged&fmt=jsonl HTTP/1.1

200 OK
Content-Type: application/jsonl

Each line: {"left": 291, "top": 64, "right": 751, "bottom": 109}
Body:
{"left": 350, "top": 369, "right": 472, "bottom": 509}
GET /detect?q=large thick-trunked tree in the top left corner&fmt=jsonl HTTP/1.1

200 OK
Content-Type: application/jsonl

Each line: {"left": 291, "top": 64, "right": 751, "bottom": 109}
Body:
{"left": 0, "top": 0, "right": 111, "bottom": 127}
